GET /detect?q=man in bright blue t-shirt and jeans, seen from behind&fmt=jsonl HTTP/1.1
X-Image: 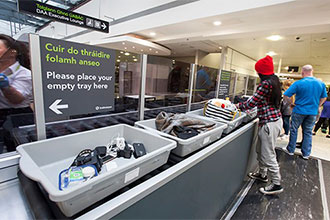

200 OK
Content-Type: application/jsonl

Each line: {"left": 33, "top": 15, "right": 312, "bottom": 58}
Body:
{"left": 284, "top": 65, "right": 327, "bottom": 160}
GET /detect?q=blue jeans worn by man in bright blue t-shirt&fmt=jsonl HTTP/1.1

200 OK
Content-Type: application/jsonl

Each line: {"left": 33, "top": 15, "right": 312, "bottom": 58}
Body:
{"left": 287, "top": 113, "right": 316, "bottom": 156}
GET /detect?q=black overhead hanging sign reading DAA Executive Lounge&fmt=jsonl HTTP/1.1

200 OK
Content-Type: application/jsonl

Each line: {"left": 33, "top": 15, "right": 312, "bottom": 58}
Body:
{"left": 18, "top": 0, "right": 109, "bottom": 33}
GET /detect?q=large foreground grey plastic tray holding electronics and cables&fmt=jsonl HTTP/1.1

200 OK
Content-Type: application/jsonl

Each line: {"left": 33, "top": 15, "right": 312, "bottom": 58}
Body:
{"left": 17, "top": 124, "right": 176, "bottom": 216}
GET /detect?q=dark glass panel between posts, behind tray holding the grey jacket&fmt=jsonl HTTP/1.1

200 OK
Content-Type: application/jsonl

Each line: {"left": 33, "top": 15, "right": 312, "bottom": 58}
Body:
{"left": 145, "top": 56, "right": 190, "bottom": 109}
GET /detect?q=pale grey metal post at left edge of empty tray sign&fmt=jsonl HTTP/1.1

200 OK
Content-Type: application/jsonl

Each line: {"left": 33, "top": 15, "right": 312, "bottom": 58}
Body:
{"left": 29, "top": 34, "right": 46, "bottom": 140}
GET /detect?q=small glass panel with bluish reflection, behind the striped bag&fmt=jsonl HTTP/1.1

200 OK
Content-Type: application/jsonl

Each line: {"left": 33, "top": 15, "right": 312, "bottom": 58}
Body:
{"left": 192, "top": 65, "right": 219, "bottom": 102}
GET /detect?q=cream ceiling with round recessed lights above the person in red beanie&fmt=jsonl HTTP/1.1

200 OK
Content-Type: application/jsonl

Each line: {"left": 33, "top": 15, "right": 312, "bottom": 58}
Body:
{"left": 131, "top": 0, "right": 330, "bottom": 74}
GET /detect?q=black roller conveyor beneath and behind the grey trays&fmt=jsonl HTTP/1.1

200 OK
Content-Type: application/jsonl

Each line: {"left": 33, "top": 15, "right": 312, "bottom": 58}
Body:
{"left": 18, "top": 102, "right": 258, "bottom": 218}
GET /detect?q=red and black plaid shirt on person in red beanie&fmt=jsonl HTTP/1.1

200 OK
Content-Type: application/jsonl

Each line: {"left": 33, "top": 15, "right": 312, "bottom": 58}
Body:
{"left": 239, "top": 80, "right": 281, "bottom": 126}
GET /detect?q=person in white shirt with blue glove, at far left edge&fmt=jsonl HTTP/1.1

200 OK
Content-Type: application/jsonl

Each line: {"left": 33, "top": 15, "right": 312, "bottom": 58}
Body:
{"left": 0, "top": 34, "right": 32, "bottom": 153}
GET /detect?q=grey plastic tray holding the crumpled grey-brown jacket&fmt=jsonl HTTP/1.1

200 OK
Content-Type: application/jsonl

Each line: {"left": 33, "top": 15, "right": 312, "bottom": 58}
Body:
{"left": 135, "top": 116, "right": 227, "bottom": 157}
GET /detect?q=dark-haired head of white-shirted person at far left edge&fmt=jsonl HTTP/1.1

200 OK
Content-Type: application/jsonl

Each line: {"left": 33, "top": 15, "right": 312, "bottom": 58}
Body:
{"left": 0, "top": 34, "right": 30, "bottom": 69}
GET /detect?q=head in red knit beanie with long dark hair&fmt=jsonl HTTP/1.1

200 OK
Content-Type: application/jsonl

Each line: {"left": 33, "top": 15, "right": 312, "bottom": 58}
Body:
{"left": 254, "top": 56, "right": 282, "bottom": 108}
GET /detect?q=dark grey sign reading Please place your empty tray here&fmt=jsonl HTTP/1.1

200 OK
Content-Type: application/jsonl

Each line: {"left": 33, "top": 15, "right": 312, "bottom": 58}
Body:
{"left": 40, "top": 37, "right": 115, "bottom": 119}
